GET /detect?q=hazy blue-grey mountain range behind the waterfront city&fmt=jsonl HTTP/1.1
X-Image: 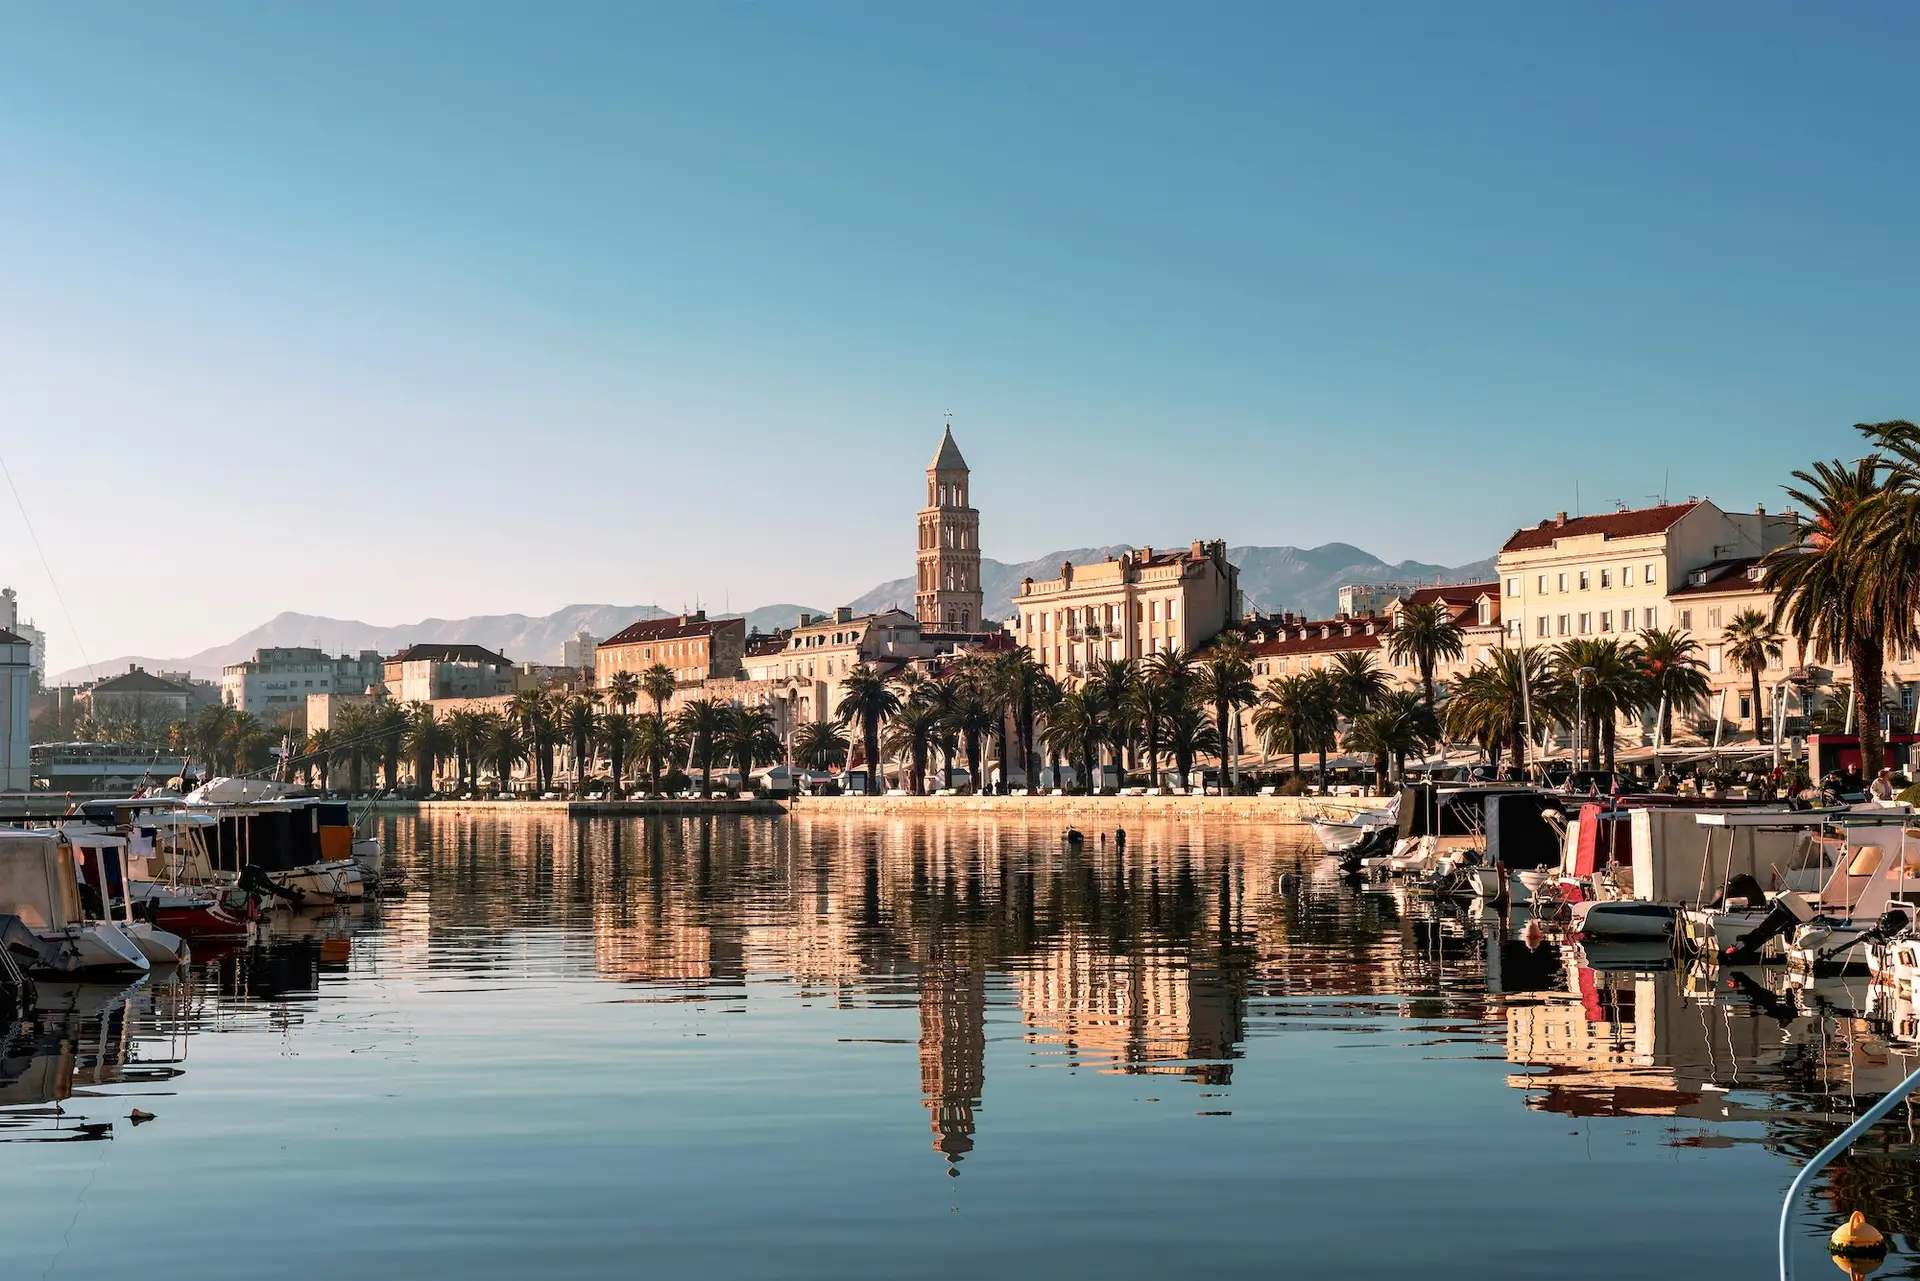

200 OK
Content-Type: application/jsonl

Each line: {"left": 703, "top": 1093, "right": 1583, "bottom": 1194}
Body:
{"left": 48, "top": 544, "right": 1494, "bottom": 684}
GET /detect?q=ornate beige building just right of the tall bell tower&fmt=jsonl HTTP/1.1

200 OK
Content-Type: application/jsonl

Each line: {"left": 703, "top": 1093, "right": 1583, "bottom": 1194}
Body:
{"left": 1014, "top": 540, "right": 1240, "bottom": 680}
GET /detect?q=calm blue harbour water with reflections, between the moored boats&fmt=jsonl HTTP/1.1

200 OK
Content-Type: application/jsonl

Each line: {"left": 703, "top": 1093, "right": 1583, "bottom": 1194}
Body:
{"left": 0, "top": 814, "right": 1920, "bottom": 1281}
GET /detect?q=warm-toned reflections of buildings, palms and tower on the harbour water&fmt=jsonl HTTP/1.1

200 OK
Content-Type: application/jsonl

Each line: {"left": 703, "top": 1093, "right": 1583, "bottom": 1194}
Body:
{"left": 11, "top": 810, "right": 1920, "bottom": 1275}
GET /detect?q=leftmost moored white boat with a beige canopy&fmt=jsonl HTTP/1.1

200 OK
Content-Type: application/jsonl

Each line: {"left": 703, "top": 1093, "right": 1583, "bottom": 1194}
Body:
{"left": 0, "top": 830, "right": 152, "bottom": 978}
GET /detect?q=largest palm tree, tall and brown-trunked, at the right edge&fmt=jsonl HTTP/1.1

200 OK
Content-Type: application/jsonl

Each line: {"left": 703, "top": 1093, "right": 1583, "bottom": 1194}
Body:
{"left": 1761, "top": 453, "right": 1914, "bottom": 778}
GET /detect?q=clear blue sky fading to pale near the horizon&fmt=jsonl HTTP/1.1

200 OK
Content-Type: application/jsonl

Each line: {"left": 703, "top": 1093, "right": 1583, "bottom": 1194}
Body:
{"left": 0, "top": 0, "right": 1920, "bottom": 670}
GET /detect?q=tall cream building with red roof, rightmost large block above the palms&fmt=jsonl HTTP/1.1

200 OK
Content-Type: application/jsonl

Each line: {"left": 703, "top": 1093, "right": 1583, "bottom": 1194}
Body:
{"left": 1498, "top": 499, "right": 1793, "bottom": 645}
